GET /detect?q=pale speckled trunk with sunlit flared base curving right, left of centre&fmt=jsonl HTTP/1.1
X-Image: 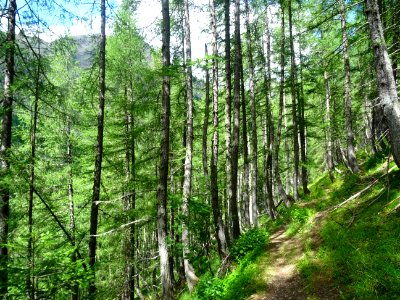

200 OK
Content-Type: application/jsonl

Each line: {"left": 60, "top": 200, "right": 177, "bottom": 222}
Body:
{"left": 182, "top": 0, "right": 199, "bottom": 292}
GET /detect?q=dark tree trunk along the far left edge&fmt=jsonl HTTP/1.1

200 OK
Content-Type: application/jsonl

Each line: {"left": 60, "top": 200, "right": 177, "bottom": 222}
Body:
{"left": 0, "top": 0, "right": 17, "bottom": 295}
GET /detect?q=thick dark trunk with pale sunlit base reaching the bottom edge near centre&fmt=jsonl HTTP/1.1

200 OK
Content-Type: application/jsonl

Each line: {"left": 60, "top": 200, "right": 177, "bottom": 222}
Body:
{"left": 157, "top": 0, "right": 173, "bottom": 300}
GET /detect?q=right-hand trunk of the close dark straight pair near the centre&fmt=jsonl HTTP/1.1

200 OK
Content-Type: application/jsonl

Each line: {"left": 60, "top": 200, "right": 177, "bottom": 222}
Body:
{"left": 229, "top": 0, "right": 241, "bottom": 240}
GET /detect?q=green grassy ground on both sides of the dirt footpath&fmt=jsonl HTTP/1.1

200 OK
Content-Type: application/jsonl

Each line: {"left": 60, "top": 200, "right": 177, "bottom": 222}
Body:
{"left": 181, "top": 155, "right": 400, "bottom": 299}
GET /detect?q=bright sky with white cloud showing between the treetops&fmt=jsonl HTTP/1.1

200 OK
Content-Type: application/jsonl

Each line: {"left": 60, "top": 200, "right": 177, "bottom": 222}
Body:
{"left": 27, "top": 0, "right": 209, "bottom": 60}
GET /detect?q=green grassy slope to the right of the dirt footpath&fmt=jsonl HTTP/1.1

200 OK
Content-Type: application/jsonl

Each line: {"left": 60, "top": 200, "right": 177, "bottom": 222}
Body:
{"left": 298, "top": 155, "right": 400, "bottom": 299}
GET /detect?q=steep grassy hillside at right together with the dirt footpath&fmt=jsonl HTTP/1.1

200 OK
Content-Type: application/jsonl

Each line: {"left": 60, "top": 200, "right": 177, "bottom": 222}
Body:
{"left": 248, "top": 156, "right": 400, "bottom": 299}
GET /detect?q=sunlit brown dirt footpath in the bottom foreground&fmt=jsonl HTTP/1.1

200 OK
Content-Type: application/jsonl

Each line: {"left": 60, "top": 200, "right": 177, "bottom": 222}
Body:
{"left": 248, "top": 228, "right": 307, "bottom": 300}
